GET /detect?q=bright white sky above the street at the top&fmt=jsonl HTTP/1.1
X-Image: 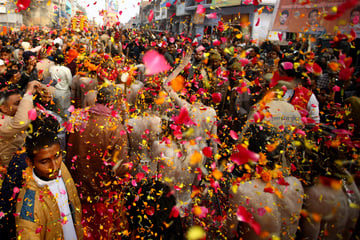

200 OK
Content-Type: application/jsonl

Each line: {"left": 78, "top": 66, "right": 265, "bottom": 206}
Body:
{"left": 77, "top": 0, "right": 141, "bottom": 24}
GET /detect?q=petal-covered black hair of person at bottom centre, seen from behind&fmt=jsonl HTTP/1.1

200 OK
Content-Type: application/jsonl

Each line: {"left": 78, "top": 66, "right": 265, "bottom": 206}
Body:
{"left": 125, "top": 180, "right": 184, "bottom": 240}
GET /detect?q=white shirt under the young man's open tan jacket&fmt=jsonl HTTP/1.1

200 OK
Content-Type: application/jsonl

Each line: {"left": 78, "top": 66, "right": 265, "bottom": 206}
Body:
{"left": 33, "top": 170, "right": 77, "bottom": 240}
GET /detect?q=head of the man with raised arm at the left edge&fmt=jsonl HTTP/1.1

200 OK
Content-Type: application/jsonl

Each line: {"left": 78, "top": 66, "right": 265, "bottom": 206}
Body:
{"left": 0, "top": 90, "right": 21, "bottom": 116}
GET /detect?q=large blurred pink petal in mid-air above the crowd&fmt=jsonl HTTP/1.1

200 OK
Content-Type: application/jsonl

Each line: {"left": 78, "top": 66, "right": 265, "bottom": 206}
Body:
{"left": 143, "top": 50, "right": 171, "bottom": 75}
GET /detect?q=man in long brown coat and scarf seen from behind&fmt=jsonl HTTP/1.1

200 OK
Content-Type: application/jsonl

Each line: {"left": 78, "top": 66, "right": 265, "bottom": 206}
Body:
{"left": 66, "top": 84, "right": 128, "bottom": 239}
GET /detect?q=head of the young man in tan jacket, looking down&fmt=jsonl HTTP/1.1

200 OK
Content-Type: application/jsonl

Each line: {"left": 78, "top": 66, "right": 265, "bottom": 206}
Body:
{"left": 25, "top": 114, "right": 62, "bottom": 181}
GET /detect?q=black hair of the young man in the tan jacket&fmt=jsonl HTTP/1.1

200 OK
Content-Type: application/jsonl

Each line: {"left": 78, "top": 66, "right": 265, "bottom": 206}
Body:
{"left": 25, "top": 113, "right": 60, "bottom": 161}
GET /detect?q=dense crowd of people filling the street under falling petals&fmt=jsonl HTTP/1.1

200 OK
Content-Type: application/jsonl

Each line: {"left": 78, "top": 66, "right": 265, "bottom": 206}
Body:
{"left": 0, "top": 23, "right": 360, "bottom": 239}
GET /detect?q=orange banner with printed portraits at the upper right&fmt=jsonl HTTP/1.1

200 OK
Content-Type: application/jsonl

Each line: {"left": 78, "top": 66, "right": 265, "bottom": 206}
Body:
{"left": 272, "top": 0, "right": 360, "bottom": 37}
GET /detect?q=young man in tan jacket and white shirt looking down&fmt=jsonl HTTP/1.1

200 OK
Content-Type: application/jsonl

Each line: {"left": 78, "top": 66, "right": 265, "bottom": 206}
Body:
{"left": 16, "top": 115, "right": 83, "bottom": 240}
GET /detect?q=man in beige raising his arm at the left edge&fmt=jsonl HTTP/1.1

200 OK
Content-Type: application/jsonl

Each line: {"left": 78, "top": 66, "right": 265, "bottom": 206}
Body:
{"left": 0, "top": 81, "right": 41, "bottom": 167}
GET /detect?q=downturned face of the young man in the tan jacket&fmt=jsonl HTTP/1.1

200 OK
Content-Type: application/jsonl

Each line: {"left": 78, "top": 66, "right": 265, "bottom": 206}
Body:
{"left": 27, "top": 144, "right": 62, "bottom": 180}
